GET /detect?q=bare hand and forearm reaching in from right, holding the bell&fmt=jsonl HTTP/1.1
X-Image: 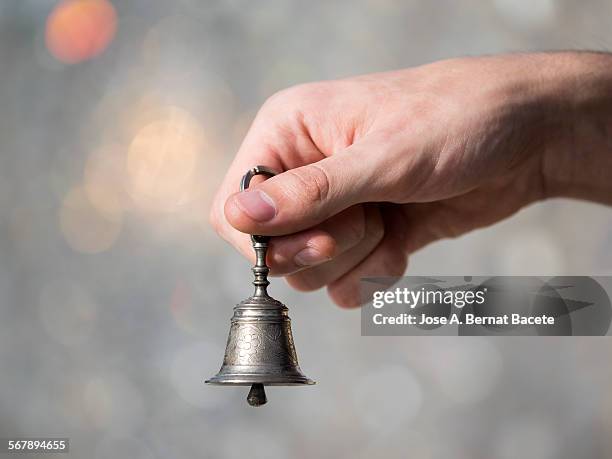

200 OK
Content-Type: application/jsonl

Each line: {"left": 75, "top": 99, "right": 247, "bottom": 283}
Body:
{"left": 210, "top": 53, "right": 612, "bottom": 307}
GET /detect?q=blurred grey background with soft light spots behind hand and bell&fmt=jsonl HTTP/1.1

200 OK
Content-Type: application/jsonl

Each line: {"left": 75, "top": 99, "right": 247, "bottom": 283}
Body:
{"left": 0, "top": 0, "right": 612, "bottom": 459}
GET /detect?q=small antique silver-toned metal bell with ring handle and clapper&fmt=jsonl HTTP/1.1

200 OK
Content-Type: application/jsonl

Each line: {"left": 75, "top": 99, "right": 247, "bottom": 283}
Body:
{"left": 206, "top": 166, "right": 314, "bottom": 406}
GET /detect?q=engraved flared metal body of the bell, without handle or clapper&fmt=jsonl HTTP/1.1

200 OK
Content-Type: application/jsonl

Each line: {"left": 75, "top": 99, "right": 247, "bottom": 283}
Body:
{"left": 206, "top": 295, "right": 314, "bottom": 386}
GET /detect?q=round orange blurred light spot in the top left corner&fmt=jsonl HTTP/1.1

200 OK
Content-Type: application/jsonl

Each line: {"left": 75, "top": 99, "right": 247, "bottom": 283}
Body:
{"left": 46, "top": 0, "right": 117, "bottom": 64}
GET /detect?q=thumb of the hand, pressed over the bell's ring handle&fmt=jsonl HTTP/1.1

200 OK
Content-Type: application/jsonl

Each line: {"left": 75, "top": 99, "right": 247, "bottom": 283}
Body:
{"left": 225, "top": 145, "right": 378, "bottom": 236}
